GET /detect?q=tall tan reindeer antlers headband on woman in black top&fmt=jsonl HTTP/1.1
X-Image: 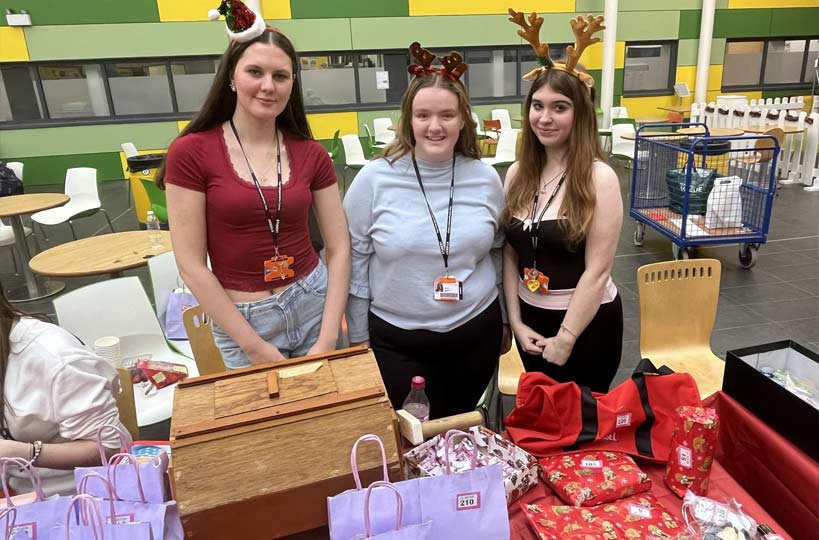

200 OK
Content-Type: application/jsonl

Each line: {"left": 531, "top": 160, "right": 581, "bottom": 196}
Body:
{"left": 509, "top": 8, "right": 606, "bottom": 88}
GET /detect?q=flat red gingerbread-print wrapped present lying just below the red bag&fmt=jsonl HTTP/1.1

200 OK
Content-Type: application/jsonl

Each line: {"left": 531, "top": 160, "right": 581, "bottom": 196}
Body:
{"left": 540, "top": 452, "right": 651, "bottom": 506}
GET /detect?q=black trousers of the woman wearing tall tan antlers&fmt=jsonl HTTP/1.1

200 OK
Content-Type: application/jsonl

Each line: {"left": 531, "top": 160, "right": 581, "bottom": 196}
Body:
{"left": 518, "top": 294, "right": 623, "bottom": 392}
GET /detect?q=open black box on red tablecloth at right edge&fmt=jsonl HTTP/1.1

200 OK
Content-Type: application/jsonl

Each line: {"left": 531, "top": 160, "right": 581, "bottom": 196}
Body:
{"left": 722, "top": 340, "right": 819, "bottom": 462}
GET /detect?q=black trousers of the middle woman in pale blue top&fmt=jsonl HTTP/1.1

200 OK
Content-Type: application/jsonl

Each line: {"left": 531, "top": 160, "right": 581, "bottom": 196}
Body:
{"left": 369, "top": 299, "right": 503, "bottom": 418}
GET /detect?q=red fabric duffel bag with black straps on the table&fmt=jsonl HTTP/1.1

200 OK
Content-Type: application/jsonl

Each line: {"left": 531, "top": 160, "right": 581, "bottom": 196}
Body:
{"left": 504, "top": 359, "right": 702, "bottom": 462}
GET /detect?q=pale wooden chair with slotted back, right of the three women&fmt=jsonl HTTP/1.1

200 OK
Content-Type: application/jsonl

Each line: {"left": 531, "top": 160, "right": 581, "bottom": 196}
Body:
{"left": 637, "top": 259, "right": 725, "bottom": 397}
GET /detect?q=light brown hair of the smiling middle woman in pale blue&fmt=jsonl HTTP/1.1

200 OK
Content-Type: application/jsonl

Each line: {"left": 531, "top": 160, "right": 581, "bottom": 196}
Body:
{"left": 379, "top": 73, "right": 481, "bottom": 163}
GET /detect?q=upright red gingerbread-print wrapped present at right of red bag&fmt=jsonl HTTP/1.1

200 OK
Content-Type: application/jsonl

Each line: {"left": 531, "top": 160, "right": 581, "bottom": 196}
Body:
{"left": 663, "top": 406, "right": 719, "bottom": 497}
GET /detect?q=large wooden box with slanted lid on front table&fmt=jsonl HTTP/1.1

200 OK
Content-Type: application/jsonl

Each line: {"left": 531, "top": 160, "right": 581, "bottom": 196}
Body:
{"left": 171, "top": 347, "right": 400, "bottom": 540}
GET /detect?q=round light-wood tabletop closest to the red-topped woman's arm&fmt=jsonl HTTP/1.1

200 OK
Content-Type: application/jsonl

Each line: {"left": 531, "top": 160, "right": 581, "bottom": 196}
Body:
{"left": 29, "top": 231, "right": 172, "bottom": 277}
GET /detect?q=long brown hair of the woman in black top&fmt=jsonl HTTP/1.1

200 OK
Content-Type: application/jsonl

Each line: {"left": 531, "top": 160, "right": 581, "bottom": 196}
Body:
{"left": 501, "top": 69, "right": 606, "bottom": 249}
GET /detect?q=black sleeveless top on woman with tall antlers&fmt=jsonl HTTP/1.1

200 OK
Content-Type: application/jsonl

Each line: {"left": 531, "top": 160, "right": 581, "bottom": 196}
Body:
{"left": 506, "top": 218, "right": 586, "bottom": 290}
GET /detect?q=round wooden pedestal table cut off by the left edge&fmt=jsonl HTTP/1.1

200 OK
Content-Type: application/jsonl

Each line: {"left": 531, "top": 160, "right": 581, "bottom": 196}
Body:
{"left": 0, "top": 193, "right": 70, "bottom": 302}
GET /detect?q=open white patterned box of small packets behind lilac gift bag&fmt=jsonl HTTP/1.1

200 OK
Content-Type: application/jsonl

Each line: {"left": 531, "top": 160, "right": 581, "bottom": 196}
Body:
{"left": 404, "top": 426, "right": 540, "bottom": 504}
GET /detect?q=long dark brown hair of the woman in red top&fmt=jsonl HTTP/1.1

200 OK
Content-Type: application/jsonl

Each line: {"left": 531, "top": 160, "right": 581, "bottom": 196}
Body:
{"left": 156, "top": 27, "right": 313, "bottom": 189}
